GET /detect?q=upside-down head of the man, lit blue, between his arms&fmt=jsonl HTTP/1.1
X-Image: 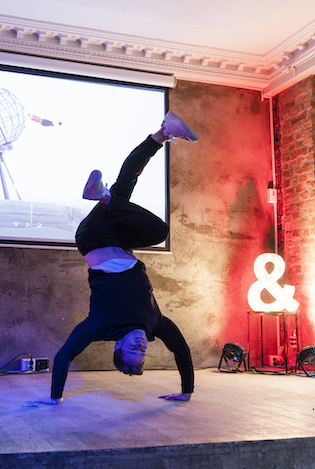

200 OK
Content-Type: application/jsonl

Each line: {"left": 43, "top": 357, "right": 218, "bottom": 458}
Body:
{"left": 114, "top": 329, "right": 148, "bottom": 375}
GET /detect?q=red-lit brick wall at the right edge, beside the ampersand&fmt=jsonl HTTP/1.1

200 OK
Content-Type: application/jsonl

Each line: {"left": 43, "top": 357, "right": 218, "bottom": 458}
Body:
{"left": 273, "top": 76, "right": 315, "bottom": 348}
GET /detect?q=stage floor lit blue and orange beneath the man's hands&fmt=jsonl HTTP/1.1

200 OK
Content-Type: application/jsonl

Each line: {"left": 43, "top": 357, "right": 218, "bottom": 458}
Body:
{"left": 0, "top": 369, "right": 315, "bottom": 469}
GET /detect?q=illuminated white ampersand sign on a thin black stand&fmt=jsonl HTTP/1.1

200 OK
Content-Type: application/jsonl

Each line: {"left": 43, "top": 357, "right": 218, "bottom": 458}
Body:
{"left": 247, "top": 253, "right": 300, "bottom": 313}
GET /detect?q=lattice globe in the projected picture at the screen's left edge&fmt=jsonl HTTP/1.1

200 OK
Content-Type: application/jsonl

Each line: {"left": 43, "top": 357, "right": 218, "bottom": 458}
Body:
{"left": 0, "top": 88, "right": 26, "bottom": 151}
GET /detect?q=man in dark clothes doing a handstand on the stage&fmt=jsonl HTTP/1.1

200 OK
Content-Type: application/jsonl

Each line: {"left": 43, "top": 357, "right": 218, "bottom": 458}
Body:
{"left": 36, "top": 111, "right": 198, "bottom": 404}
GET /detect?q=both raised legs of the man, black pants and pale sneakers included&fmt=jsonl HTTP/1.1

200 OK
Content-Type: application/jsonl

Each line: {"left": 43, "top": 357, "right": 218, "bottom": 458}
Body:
{"left": 77, "top": 111, "right": 198, "bottom": 255}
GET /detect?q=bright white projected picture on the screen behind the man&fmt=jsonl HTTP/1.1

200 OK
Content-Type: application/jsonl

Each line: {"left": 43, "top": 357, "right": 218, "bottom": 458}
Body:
{"left": 0, "top": 71, "right": 166, "bottom": 249}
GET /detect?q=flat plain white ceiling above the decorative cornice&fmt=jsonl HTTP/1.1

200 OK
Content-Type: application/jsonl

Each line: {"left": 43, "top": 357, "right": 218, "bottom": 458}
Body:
{"left": 0, "top": 0, "right": 315, "bottom": 55}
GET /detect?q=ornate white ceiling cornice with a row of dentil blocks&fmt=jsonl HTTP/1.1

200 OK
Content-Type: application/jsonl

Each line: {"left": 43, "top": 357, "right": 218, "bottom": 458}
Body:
{"left": 0, "top": 15, "right": 315, "bottom": 96}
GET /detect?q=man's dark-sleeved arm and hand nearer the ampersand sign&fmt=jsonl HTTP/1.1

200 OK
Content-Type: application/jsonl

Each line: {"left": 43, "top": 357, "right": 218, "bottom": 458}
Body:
{"left": 156, "top": 316, "right": 194, "bottom": 401}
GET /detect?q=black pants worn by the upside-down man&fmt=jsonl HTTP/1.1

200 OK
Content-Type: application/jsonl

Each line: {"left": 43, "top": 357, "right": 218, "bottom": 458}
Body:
{"left": 76, "top": 137, "right": 168, "bottom": 255}
